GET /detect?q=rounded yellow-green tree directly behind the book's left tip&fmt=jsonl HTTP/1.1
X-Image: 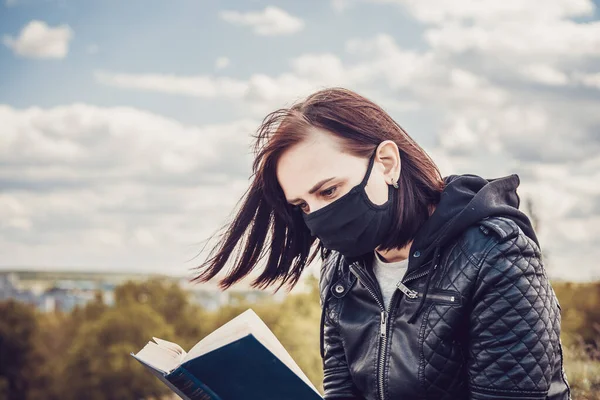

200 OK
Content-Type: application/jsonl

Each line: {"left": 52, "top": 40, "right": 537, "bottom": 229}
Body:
{"left": 59, "top": 304, "right": 174, "bottom": 400}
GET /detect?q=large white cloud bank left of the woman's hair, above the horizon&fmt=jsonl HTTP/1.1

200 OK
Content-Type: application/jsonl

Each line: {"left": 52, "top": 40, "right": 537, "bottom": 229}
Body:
{"left": 0, "top": 104, "right": 258, "bottom": 273}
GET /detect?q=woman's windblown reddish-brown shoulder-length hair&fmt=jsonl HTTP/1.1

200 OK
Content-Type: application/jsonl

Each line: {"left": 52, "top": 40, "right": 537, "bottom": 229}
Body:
{"left": 192, "top": 88, "right": 443, "bottom": 290}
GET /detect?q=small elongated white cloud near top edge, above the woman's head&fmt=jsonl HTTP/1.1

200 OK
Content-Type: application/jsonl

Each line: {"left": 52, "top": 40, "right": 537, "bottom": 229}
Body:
{"left": 219, "top": 6, "right": 304, "bottom": 36}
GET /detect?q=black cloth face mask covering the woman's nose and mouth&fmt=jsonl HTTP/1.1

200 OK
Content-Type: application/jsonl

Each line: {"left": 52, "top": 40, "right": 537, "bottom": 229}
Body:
{"left": 302, "top": 152, "right": 395, "bottom": 257}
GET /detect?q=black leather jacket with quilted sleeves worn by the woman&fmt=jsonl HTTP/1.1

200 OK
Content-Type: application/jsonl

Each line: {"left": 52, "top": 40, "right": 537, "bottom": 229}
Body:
{"left": 320, "top": 175, "right": 570, "bottom": 400}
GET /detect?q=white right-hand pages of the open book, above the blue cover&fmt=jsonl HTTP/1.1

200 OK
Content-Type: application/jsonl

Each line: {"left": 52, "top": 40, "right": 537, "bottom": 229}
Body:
{"left": 181, "top": 309, "right": 320, "bottom": 395}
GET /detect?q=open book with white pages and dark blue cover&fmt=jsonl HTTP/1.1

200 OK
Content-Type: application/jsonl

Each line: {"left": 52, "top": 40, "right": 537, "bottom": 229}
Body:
{"left": 131, "top": 309, "right": 322, "bottom": 400}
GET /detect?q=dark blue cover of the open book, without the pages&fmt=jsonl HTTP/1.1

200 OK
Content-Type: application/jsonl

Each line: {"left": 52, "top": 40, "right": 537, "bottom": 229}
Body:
{"left": 165, "top": 334, "right": 322, "bottom": 400}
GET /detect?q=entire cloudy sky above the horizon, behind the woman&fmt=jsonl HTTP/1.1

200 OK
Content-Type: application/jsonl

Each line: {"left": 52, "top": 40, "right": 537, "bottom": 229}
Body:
{"left": 0, "top": 0, "right": 600, "bottom": 280}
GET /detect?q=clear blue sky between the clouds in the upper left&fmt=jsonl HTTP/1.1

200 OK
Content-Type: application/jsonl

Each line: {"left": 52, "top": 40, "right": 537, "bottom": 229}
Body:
{"left": 0, "top": 0, "right": 420, "bottom": 123}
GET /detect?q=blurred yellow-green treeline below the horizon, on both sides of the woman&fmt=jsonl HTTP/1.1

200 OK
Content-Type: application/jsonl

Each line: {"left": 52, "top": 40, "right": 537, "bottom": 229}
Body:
{"left": 0, "top": 279, "right": 600, "bottom": 400}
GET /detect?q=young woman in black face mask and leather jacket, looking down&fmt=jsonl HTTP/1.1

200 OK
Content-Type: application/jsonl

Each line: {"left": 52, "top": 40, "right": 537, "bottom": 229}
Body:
{"left": 196, "top": 88, "right": 570, "bottom": 400}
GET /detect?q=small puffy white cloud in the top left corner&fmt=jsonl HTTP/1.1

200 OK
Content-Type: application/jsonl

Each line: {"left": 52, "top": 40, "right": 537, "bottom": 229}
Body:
{"left": 3, "top": 20, "right": 73, "bottom": 58}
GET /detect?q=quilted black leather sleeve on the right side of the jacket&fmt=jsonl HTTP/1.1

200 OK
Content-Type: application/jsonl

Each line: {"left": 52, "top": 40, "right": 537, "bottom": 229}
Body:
{"left": 460, "top": 217, "right": 568, "bottom": 398}
